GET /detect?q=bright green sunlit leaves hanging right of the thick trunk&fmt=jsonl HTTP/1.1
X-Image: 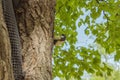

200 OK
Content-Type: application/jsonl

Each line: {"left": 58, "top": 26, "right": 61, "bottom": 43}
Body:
{"left": 53, "top": 0, "right": 120, "bottom": 80}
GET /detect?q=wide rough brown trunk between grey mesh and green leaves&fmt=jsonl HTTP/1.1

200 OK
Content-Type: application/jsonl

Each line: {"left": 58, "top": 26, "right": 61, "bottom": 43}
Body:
{"left": 16, "top": 0, "right": 55, "bottom": 80}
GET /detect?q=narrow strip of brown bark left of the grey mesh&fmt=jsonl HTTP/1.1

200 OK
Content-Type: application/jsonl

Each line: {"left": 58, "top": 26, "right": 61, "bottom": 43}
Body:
{"left": 0, "top": 0, "right": 14, "bottom": 80}
